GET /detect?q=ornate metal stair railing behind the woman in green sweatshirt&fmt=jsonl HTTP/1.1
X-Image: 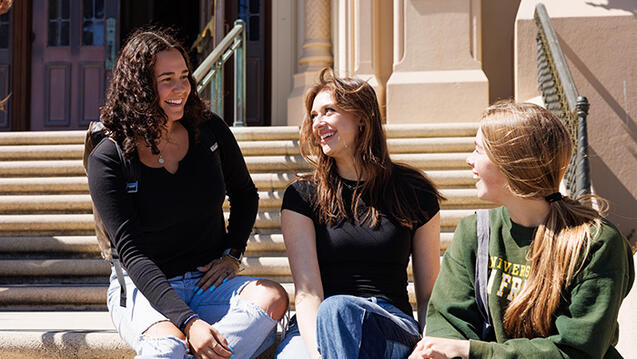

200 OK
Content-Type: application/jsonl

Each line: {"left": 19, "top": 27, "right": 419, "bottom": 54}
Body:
{"left": 535, "top": 3, "right": 591, "bottom": 198}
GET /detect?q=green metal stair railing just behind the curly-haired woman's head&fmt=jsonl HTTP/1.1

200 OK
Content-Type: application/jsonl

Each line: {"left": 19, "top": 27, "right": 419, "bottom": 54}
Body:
{"left": 193, "top": 19, "right": 246, "bottom": 126}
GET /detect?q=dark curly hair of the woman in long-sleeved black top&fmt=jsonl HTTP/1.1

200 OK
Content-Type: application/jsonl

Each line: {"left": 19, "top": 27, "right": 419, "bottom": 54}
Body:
{"left": 100, "top": 28, "right": 212, "bottom": 159}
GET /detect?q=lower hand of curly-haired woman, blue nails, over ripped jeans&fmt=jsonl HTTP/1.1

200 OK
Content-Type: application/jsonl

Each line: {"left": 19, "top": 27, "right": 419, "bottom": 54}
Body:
{"left": 184, "top": 318, "right": 233, "bottom": 359}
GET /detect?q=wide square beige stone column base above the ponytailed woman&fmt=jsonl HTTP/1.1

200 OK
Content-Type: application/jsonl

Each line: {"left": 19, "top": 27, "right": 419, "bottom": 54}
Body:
{"left": 387, "top": 0, "right": 489, "bottom": 123}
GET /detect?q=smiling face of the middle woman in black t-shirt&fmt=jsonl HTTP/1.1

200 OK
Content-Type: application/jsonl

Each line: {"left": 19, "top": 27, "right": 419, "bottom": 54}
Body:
{"left": 310, "top": 91, "right": 360, "bottom": 160}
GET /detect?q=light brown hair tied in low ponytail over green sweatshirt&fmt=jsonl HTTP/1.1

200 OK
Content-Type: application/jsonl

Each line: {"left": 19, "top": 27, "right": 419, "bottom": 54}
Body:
{"left": 480, "top": 102, "right": 606, "bottom": 338}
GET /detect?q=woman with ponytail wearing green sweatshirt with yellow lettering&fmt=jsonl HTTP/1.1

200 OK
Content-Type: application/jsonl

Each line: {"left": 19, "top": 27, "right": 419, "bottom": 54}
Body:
{"left": 410, "top": 102, "right": 635, "bottom": 359}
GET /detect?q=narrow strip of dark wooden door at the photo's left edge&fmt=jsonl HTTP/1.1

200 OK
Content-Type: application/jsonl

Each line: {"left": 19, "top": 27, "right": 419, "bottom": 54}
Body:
{"left": 0, "top": 10, "right": 13, "bottom": 131}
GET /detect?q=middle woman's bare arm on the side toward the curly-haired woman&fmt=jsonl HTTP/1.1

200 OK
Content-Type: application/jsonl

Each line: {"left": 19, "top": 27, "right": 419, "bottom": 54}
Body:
{"left": 281, "top": 209, "right": 323, "bottom": 358}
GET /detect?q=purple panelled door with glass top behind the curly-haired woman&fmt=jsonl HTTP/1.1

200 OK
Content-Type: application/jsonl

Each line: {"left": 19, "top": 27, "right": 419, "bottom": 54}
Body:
{"left": 31, "top": 0, "right": 119, "bottom": 131}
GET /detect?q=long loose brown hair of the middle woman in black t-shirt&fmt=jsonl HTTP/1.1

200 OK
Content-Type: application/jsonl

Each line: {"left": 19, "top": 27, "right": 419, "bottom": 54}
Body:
{"left": 300, "top": 68, "right": 444, "bottom": 229}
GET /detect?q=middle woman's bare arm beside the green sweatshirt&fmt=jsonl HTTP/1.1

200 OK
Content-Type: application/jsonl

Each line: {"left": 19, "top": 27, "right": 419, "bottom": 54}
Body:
{"left": 412, "top": 212, "right": 440, "bottom": 330}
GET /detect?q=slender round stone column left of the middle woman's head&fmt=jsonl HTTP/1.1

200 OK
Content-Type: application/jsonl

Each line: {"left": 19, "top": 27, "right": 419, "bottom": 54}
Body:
{"left": 287, "top": 0, "right": 333, "bottom": 125}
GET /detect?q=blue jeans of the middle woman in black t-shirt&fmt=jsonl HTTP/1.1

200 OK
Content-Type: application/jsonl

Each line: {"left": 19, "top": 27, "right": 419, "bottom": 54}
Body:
{"left": 275, "top": 295, "right": 420, "bottom": 359}
